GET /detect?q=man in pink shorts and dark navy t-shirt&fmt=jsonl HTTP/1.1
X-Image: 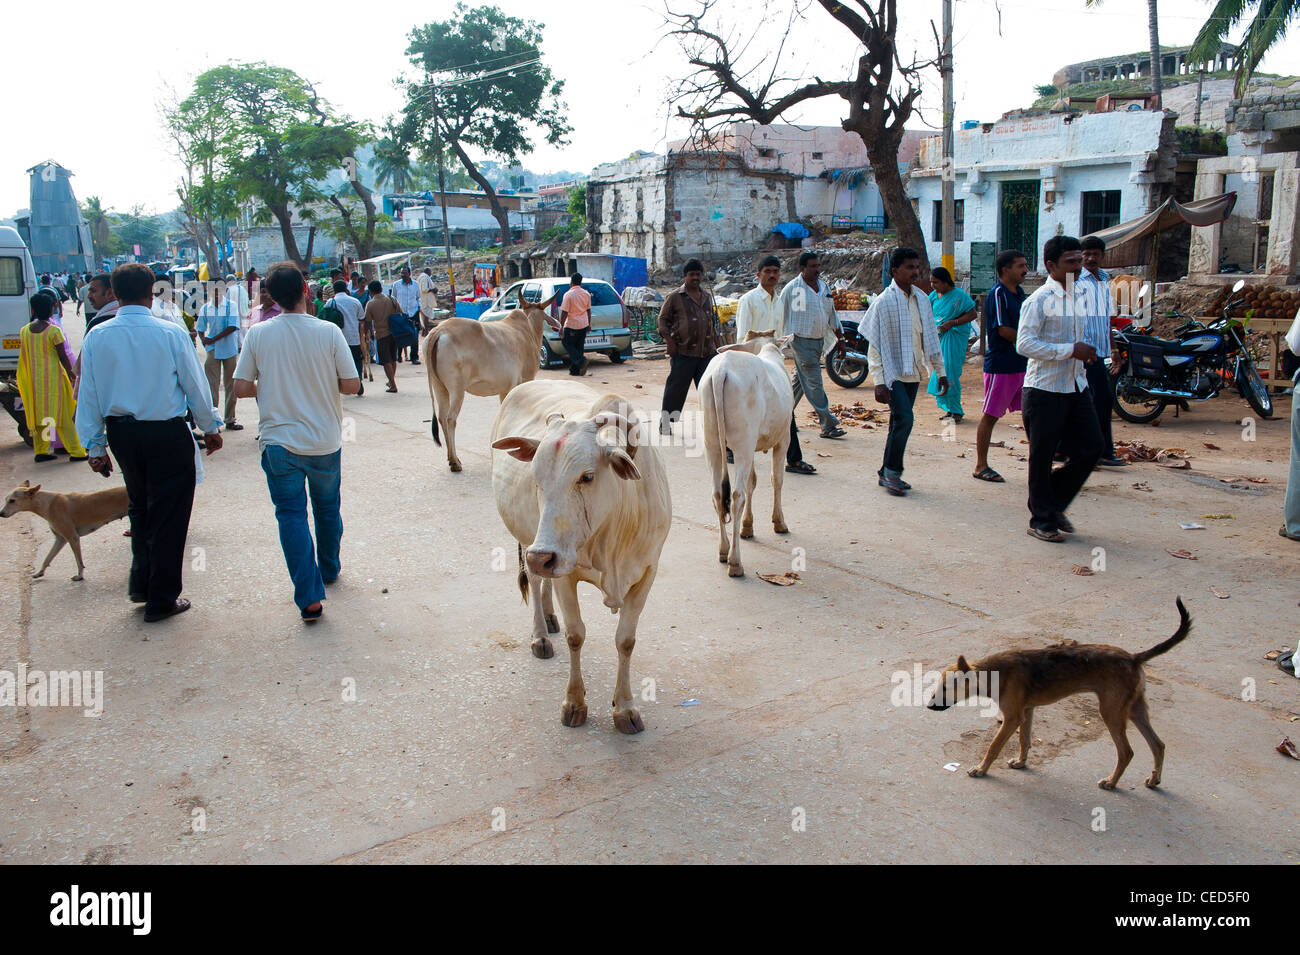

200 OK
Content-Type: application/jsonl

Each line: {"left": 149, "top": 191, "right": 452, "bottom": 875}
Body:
{"left": 974, "top": 248, "right": 1030, "bottom": 485}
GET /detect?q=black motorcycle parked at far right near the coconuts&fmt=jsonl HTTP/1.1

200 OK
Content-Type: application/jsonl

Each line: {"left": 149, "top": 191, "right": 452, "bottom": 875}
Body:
{"left": 1110, "top": 281, "right": 1273, "bottom": 425}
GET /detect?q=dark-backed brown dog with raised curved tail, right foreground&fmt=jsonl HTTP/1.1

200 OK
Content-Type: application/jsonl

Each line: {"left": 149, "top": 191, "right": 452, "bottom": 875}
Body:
{"left": 928, "top": 598, "right": 1192, "bottom": 789}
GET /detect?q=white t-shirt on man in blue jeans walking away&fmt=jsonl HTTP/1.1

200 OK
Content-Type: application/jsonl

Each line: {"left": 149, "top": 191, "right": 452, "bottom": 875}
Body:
{"left": 235, "top": 312, "right": 356, "bottom": 455}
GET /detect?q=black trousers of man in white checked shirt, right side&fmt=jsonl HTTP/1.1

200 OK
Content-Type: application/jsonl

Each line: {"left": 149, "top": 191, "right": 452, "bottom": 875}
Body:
{"left": 1021, "top": 388, "right": 1101, "bottom": 531}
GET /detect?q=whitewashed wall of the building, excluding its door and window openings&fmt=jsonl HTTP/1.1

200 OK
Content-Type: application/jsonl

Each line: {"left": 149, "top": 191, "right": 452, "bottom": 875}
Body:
{"left": 909, "top": 110, "right": 1174, "bottom": 274}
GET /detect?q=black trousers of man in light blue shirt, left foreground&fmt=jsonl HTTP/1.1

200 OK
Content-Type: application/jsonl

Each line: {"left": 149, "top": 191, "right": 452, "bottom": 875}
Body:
{"left": 107, "top": 417, "right": 195, "bottom": 613}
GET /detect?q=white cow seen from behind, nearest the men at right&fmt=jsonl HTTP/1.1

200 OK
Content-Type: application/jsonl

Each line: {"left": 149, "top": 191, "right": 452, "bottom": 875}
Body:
{"left": 699, "top": 333, "right": 794, "bottom": 577}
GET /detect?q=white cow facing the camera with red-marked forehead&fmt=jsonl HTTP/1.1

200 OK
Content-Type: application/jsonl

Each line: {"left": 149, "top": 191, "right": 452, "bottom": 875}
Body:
{"left": 491, "top": 379, "right": 672, "bottom": 733}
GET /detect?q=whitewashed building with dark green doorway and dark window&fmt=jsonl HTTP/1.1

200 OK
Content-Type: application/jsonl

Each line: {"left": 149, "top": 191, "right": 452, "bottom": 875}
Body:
{"left": 907, "top": 109, "right": 1178, "bottom": 275}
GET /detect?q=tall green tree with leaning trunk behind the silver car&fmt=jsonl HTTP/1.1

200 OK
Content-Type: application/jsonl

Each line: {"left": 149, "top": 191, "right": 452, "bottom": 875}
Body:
{"left": 402, "top": 3, "right": 571, "bottom": 248}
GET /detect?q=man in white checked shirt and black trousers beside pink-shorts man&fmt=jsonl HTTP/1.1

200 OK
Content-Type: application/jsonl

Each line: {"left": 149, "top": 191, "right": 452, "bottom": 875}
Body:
{"left": 1015, "top": 235, "right": 1101, "bottom": 543}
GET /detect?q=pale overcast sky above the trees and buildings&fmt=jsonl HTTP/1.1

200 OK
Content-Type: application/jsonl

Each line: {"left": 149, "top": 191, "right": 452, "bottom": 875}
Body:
{"left": 0, "top": 0, "right": 1300, "bottom": 216}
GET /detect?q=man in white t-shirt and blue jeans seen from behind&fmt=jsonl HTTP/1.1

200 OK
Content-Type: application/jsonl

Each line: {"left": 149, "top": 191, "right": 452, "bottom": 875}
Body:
{"left": 235, "top": 262, "right": 361, "bottom": 621}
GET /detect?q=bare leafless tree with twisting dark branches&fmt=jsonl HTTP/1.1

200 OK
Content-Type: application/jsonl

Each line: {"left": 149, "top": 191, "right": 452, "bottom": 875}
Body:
{"left": 666, "top": 0, "right": 937, "bottom": 269}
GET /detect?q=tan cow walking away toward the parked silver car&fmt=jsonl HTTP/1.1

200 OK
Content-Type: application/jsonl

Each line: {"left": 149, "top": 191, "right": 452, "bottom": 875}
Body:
{"left": 424, "top": 300, "right": 558, "bottom": 470}
